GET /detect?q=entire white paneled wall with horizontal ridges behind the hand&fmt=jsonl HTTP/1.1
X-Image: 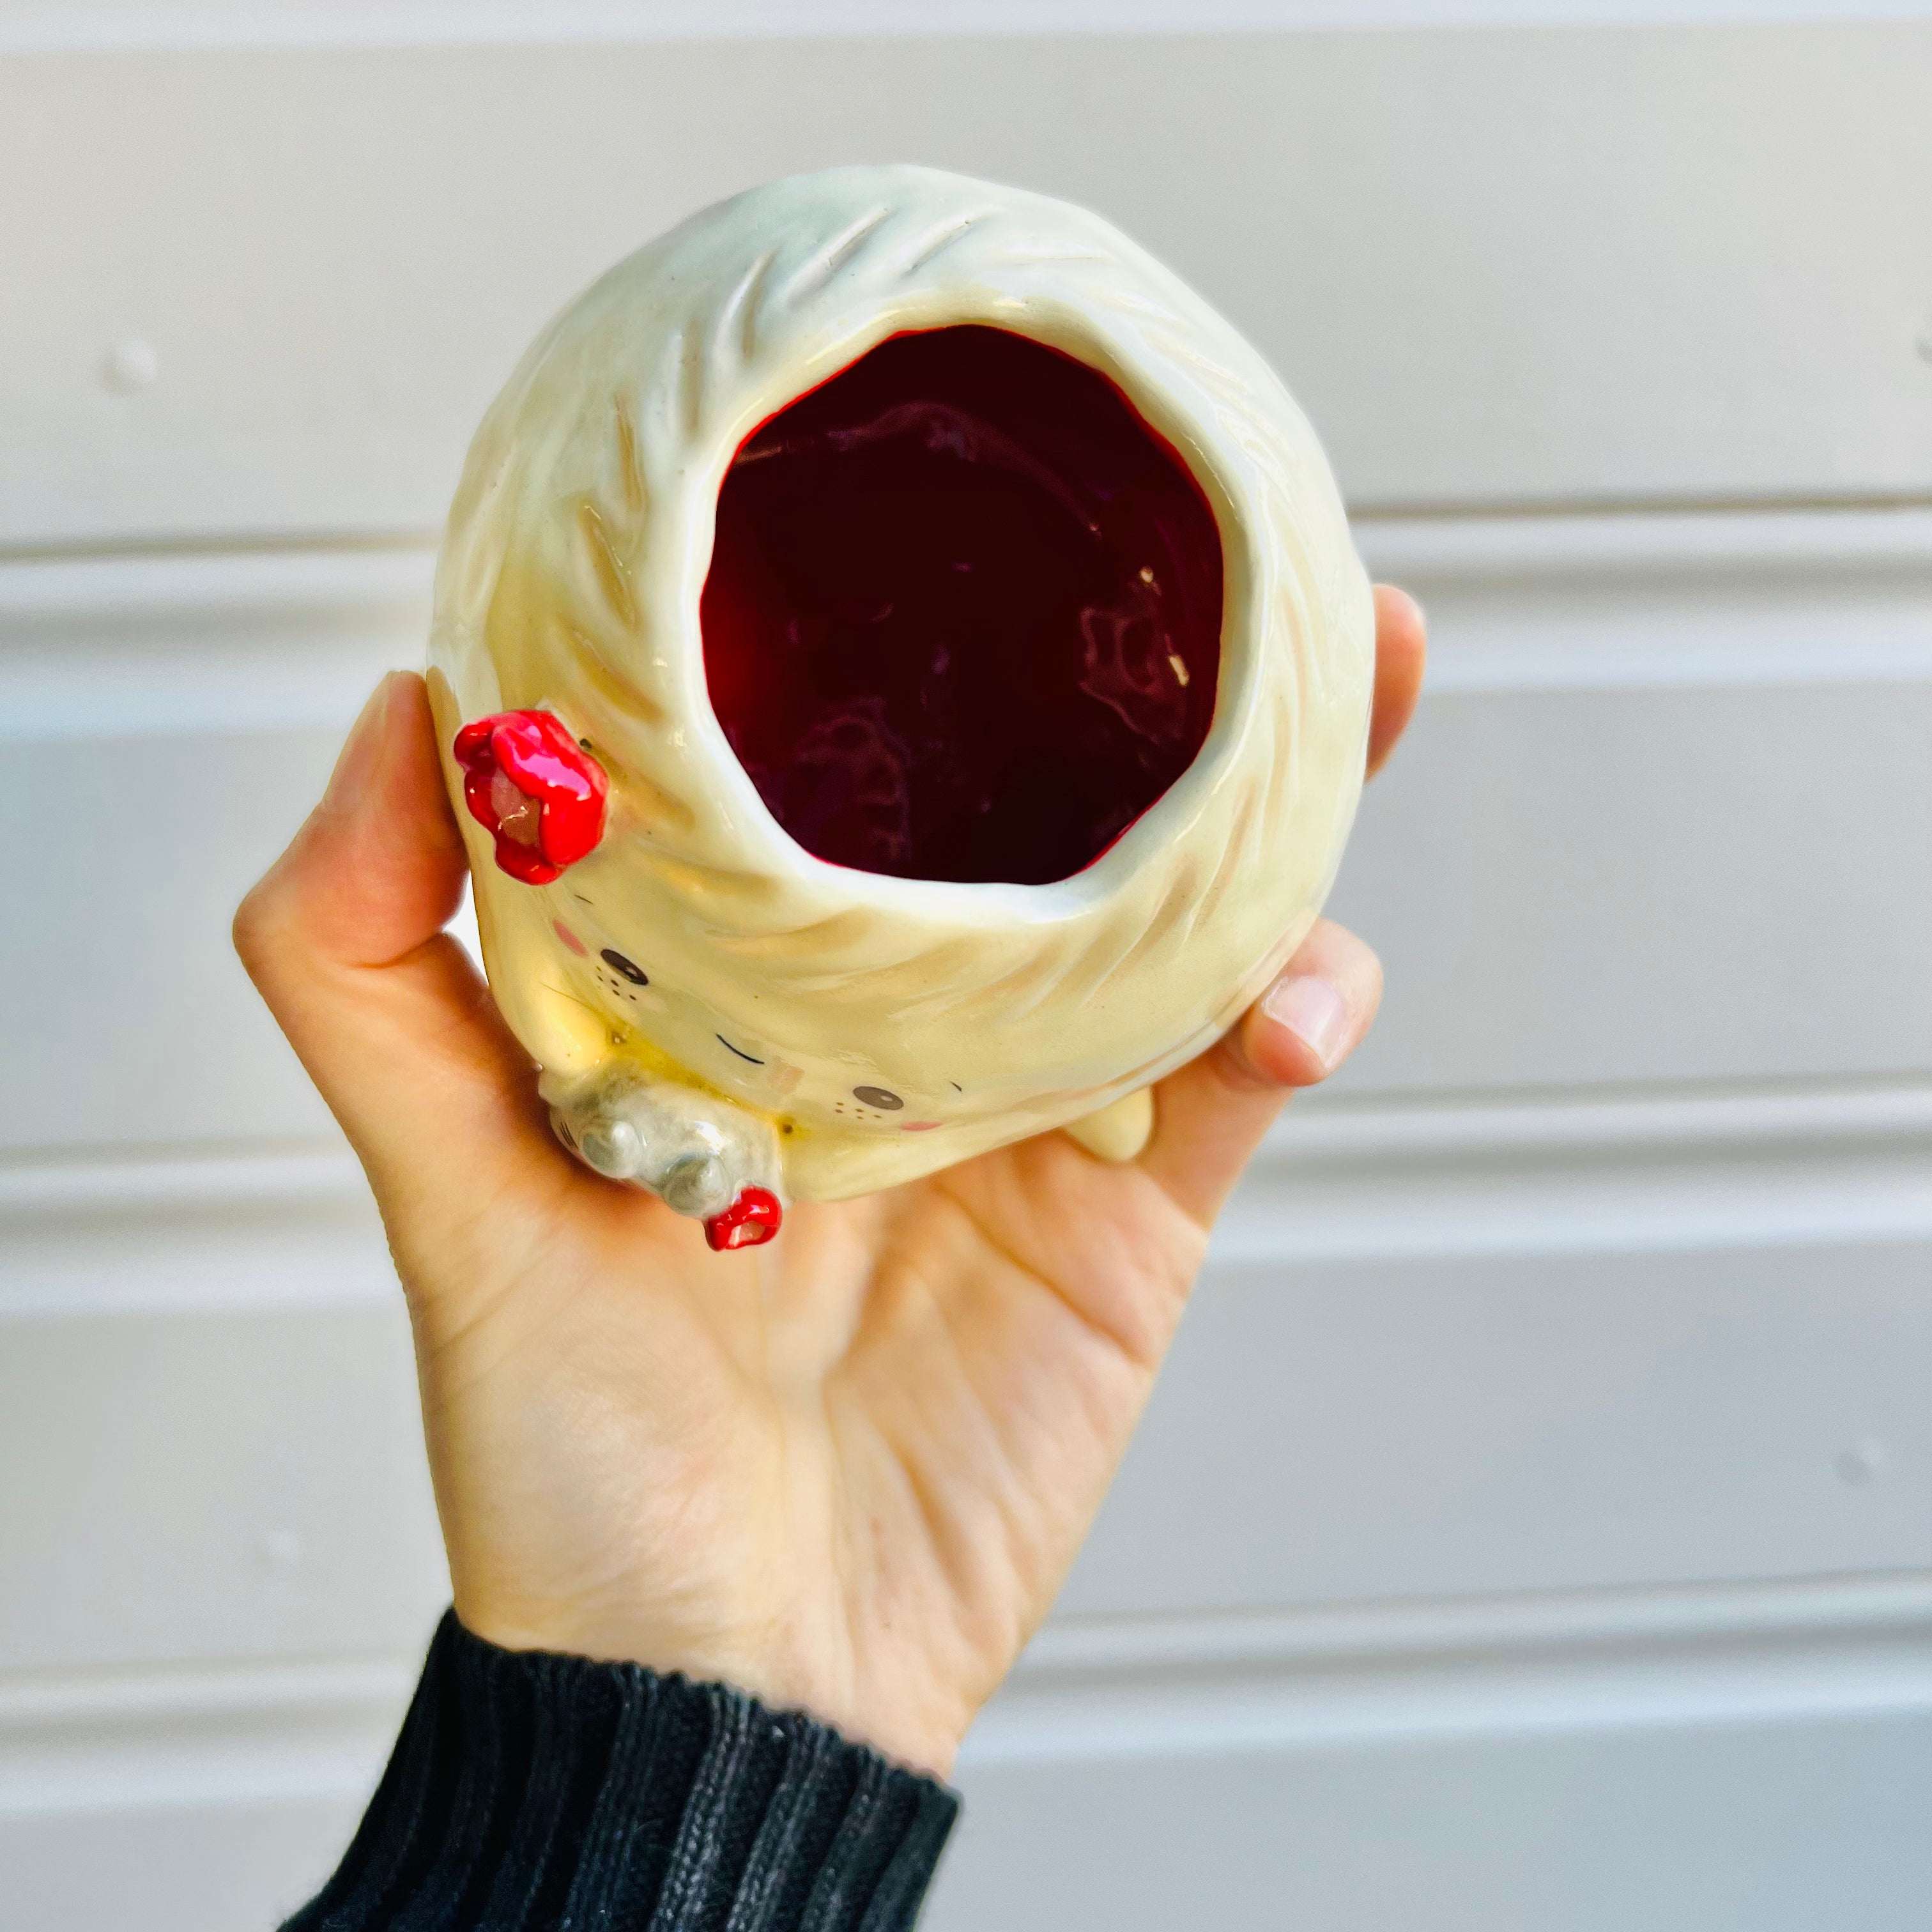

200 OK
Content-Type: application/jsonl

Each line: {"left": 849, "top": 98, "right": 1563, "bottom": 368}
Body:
{"left": 0, "top": 15, "right": 1932, "bottom": 1932}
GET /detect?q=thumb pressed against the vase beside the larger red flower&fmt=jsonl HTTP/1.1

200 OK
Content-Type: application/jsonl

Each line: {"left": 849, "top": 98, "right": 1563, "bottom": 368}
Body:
{"left": 234, "top": 670, "right": 555, "bottom": 1196}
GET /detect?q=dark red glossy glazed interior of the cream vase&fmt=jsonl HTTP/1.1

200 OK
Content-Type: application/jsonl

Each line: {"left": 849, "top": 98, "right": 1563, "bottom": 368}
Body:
{"left": 702, "top": 326, "right": 1221, "bottom": 885}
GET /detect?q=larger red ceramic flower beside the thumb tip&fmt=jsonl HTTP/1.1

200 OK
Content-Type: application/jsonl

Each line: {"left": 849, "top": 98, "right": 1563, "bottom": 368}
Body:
{"left": 456, "top": 711, "right": 611, "bottom": 885}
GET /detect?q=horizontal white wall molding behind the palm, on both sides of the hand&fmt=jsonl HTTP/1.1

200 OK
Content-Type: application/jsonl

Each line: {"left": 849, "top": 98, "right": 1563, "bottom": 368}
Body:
{"left": 0, "top": 1082, "right": 1932, "bottom": 1319}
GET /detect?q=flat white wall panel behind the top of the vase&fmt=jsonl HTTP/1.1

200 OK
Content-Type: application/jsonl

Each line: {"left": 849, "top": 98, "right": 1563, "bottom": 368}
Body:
{"left": 11, "top": 28, "right": 1932, "bottom": 543}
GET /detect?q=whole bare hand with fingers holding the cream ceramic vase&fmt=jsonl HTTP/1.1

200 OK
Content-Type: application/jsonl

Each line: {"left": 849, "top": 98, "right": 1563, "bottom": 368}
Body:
{"left": 236, "top": 589, "right": 1424, "bottom": 1775}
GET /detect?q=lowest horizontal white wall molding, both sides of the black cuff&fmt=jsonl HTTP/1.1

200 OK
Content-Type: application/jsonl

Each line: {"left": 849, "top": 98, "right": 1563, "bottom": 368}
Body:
{"left": 0, "top": 1573, "right": 1932, "bottom": 1818}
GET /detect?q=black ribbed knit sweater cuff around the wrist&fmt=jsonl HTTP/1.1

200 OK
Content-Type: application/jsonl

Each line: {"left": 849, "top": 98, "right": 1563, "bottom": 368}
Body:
{"left": 284, "top": 1611, "right": 958, "bottom": 1932}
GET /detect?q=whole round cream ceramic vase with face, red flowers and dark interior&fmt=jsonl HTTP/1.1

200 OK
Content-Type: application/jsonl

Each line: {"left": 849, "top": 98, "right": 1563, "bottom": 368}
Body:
{"left": 431, "top": 168, "right": 1374, "bottom": 1248}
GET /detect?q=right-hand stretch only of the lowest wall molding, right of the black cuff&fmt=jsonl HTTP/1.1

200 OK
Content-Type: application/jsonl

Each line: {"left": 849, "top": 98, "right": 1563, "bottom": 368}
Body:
{"left": 960, "top": 1573, "right": 1932, "bottom": 1775}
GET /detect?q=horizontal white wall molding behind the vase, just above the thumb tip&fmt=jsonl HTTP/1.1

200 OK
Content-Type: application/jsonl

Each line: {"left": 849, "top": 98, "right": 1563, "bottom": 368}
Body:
{"left": 0, "top": 508, "right": 1932, "bottom": 738}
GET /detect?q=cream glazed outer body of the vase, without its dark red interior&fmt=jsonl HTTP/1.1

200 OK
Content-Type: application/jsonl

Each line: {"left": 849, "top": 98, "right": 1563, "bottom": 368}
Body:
{"left": 429, "top": 166, "right": 1374, "bottom": 1246}
